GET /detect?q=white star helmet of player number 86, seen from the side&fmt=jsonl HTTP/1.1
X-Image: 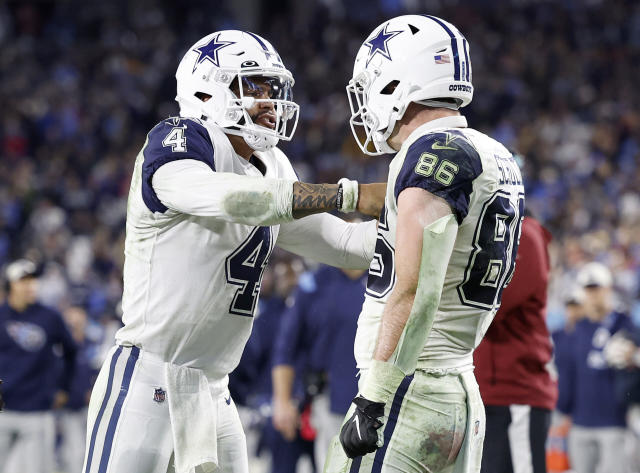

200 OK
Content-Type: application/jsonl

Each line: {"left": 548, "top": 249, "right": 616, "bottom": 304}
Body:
{"left": 347, "top": 15, "right": 473, "bottom": 156}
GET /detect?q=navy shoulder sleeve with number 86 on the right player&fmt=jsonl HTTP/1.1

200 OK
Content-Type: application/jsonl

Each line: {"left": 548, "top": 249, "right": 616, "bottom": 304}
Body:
{"left": 394, "top": 131, "right": 482, "bottom": 224}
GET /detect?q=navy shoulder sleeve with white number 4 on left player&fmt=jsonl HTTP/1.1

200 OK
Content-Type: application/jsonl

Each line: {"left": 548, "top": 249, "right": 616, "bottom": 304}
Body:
{"left": 142, "top": 117, "right": 216, "bottom": 213}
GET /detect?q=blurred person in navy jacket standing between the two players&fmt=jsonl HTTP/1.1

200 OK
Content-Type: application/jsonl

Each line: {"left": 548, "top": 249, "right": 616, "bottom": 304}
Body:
{"left": 272, "top": 266, "right": 366, "bottom": 468}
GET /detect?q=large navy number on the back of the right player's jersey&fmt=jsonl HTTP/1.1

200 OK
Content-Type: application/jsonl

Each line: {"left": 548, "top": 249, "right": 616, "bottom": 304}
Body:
{"left": 458, "top": 191, "right": 524, "bottom": 309}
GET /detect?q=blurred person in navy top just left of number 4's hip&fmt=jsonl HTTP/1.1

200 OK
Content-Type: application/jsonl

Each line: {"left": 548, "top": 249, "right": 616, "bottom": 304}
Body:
{"left": 58, "top": 305, "right": 101, "bottom": 473}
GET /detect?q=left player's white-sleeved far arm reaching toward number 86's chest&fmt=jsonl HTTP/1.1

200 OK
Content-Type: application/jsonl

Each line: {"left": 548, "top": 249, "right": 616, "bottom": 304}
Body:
{"left": 277, "top": 214, "right": 377, "bottom": 269}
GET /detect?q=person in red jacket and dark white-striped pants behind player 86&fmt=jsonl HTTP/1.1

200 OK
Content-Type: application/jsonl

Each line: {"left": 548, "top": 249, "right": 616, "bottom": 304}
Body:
{"left": 473, "top": 216, "right": 558, "bottom": 473}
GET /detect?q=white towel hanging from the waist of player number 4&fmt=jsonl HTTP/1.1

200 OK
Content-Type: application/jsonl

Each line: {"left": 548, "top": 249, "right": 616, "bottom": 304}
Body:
{"left": 165, "top": 363, "right": 218, "bottom": 473}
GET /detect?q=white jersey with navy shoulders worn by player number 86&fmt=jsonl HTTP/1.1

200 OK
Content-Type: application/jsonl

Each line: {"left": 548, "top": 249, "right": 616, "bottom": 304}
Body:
{"left": 355, "top": 116, "right": 524, "bottom": 369}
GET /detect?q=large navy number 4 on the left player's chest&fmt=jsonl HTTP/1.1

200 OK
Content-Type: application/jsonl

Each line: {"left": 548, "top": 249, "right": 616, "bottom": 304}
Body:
{"left": 225, "top": 227, "right": 272, "bottom": 317}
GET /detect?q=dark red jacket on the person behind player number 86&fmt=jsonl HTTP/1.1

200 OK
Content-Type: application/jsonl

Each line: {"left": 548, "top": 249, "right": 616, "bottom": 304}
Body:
{"left": 473, "top": 217, "right": 558, "bottom": 409}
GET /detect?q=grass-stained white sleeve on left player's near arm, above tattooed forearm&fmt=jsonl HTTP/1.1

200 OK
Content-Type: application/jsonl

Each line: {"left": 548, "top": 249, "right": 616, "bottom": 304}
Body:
{"left": 152, "top": 159, "right": 294, "bottom": 226}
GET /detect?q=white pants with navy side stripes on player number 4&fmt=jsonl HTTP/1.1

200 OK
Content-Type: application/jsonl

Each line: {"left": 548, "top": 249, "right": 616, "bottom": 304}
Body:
{"left": 82, "top": 347, "right": 249, "bottom": 473}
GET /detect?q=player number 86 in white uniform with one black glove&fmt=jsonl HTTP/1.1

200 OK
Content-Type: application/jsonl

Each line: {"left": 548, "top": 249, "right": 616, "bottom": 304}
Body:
{"left": 325, "top": 15, "right": 524, "bottom": 473}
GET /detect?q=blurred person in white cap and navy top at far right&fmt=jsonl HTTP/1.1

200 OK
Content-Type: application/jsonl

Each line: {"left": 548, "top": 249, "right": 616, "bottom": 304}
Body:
{"left": 558, "top": 262, "right": 633, "bottom": 473}
